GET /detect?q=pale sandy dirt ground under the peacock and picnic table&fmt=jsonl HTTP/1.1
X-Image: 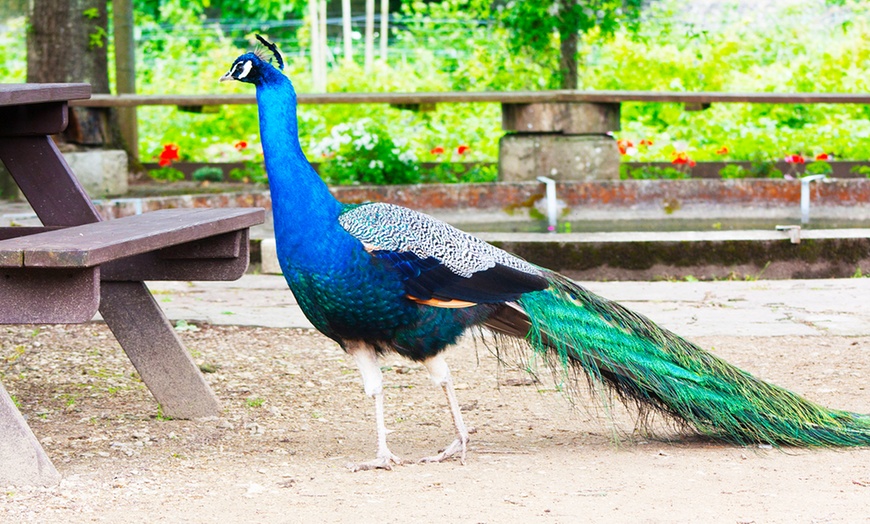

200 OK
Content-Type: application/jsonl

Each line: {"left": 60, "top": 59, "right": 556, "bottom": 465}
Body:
{"left": 0, "top": 323, "right": 870, "bottom": 523}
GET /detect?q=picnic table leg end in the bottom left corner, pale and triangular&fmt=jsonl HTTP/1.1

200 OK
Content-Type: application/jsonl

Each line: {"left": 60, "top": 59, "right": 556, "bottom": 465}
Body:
{"left": 0, "top": 384, "right": 60, "bottom": 486}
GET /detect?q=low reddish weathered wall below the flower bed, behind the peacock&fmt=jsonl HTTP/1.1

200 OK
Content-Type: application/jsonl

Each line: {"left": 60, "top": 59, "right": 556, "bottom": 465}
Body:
{"left": 95, "top": 178, "right": 870, "bottom": 219}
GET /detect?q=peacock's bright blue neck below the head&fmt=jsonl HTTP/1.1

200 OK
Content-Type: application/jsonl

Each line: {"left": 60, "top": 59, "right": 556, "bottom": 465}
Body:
{"left": 257, "top": 68, "right": 347, "bottom": 272}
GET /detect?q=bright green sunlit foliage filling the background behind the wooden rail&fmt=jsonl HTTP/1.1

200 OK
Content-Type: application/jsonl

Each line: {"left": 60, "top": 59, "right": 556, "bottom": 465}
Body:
{"left": 0, "top": 0, "right": 870, "bottom": 181}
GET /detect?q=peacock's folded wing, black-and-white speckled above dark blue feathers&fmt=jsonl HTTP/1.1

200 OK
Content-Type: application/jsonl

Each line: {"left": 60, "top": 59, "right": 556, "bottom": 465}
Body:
{"left": 338, "top": 203, "right": 549, "bottom": 306}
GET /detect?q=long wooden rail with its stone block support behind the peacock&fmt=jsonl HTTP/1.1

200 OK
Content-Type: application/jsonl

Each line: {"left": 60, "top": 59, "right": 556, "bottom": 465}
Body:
{"left": 71, "top": 90, "right": 870, "bottom": 181}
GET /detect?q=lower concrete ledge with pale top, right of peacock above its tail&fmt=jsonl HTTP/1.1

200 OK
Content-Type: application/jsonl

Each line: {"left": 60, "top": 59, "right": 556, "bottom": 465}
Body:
{"left": 478, "top": 229, "right": 870, "bottom": 280}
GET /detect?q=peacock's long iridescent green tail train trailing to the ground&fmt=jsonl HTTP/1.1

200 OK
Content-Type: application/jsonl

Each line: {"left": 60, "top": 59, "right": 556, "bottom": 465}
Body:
{"left": 518, "top": 274, "right": 870, "bottom": 446}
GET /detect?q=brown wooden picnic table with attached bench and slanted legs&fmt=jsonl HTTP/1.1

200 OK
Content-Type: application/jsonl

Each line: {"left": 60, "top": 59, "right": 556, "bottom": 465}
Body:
{"left": 0, "top": 84, "right": 265, "bottom": 485}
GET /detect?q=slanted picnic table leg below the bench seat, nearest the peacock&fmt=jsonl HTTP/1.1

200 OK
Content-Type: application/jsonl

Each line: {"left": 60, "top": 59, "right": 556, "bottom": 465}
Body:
{"left": 100, "top": 282, "right": 220, "bottom": 418}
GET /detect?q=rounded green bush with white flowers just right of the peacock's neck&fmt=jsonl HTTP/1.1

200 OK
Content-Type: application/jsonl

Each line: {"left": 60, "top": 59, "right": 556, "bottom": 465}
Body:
{"left": 312, "top": 119, "right": 420, "bottom": 185}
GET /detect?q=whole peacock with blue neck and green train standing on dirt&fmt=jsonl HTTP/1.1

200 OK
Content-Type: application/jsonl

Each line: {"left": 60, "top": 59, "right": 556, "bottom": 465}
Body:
{"left": 221, "top": 35, "right": 870, "bottom": 470}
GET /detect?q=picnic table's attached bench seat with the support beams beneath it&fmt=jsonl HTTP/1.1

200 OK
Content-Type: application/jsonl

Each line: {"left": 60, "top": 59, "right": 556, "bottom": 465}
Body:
{"left": 0, "top": 208, "right": 265, "bottom": 324}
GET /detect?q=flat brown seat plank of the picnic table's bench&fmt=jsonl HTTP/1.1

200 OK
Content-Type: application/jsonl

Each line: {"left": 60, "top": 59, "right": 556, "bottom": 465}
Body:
{"left": 0, "top": 208, "right": 265, "bottom": 267}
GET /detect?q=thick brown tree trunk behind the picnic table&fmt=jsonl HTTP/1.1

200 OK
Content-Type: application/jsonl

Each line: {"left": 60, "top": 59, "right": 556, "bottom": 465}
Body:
{"left": 27, "top": 0, "right": 115, "bottom": 146}
